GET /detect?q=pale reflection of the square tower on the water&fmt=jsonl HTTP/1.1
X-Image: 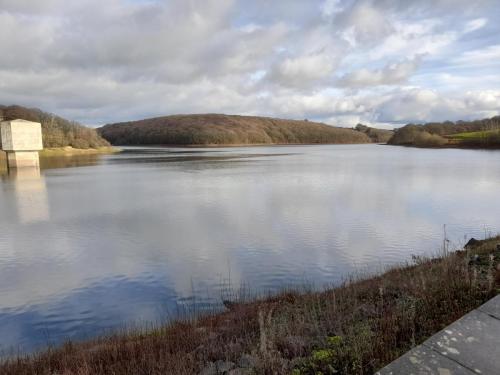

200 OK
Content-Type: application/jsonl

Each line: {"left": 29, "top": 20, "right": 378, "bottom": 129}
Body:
{"left": 8, "top": 168, "right": 49, "bottom": 224}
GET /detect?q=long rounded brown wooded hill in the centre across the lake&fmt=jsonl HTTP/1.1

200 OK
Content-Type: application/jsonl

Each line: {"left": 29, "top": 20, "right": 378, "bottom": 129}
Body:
{"left": 98, "top": 114, "right": 370, "bottom": 145}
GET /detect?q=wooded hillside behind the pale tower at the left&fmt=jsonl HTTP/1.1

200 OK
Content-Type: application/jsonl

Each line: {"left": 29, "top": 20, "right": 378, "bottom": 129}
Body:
{"left": 0, "top": 105, "right": 109, "bottom": 149}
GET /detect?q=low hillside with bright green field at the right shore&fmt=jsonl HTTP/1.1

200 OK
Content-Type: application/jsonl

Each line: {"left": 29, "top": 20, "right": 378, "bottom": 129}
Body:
{"left": 389, "top": 116, "right": 500, "bottom": 148}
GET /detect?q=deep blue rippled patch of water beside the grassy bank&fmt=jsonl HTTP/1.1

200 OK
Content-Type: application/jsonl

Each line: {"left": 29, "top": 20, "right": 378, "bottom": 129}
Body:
{"left": 0, "top": 277, "right": 177, "bottom": 358}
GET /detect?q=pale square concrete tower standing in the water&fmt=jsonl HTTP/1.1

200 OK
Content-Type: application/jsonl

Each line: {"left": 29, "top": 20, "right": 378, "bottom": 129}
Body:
{"left": 0, "top": 120, "right": 43, "bottom": 168}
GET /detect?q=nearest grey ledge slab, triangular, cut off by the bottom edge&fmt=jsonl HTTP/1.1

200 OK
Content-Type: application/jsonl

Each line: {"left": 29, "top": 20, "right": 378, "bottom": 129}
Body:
{"left": 375, "top": 345, "right": 474, "bottom": 375}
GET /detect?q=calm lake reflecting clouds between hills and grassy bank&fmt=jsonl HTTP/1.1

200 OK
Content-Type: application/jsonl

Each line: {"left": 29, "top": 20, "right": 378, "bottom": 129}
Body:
{"left": 0, "top": 145, "right": 500, "bottom": 355}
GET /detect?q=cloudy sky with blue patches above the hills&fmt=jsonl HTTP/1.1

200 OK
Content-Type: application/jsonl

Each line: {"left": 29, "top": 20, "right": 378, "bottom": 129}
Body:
{"left": 0, "top": 0, "right": 500, "bottom": 128}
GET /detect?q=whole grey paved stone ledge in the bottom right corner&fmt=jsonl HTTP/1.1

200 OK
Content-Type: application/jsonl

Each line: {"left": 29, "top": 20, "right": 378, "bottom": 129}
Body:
{"left": 376, "top": 295, "right": 500, "bottom": 375}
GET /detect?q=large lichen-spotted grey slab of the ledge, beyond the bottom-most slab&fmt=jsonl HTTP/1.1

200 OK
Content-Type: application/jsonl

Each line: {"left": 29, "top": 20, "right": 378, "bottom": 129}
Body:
{"left": 423, "top": 307, "right": 500, "bottom": 374}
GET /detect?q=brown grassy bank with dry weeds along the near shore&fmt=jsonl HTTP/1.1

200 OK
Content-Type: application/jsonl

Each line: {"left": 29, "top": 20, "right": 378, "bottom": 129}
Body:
{"left": 0, "top": 237, "right": 500, "bottom": 375}
